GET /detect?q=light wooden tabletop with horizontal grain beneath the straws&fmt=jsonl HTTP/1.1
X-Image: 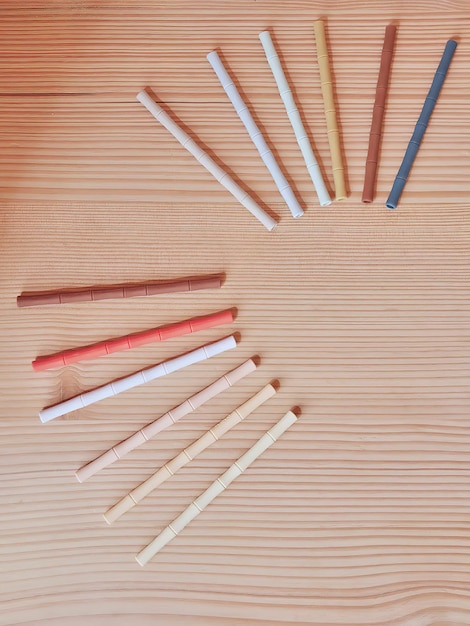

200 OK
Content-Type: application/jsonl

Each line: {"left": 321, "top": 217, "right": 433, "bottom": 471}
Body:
{"left": 0, "top": 0, "right": 470, "bottom": 626}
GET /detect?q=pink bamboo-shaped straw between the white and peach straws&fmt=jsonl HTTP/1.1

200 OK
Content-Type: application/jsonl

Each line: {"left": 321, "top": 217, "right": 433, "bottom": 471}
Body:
{"left": 75, "top": 359, "right": 256, "bottom": 483}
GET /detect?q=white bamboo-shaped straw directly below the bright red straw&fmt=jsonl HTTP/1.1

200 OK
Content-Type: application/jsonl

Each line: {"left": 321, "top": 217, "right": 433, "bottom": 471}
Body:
{"left": 39, "top": 335, "right": 237, "bottom": 423}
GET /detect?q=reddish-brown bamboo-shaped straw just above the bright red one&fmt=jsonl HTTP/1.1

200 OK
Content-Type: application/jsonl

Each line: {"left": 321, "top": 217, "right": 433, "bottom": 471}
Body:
{"left": 16, "top": 276, "right": 222, "bottom": 307}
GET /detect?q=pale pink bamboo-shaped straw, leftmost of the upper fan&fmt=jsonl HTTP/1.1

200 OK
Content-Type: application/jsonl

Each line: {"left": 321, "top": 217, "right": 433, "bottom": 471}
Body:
{"left": 137, "top": 91, "right": 276, "bottom": 230}
